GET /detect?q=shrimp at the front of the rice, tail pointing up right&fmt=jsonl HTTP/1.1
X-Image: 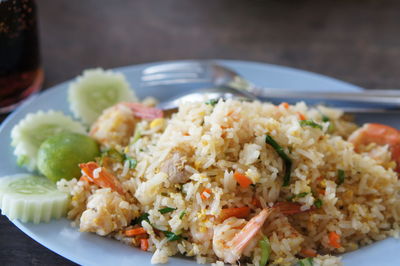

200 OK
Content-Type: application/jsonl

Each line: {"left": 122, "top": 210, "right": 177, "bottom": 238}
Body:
{"left": 213, "top": 208, "right": 272, "bottom": 263}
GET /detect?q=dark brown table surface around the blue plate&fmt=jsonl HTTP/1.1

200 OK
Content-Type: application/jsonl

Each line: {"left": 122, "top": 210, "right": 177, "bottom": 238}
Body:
{"left": 0, "top": 0, "right": 400, "bottom": 265}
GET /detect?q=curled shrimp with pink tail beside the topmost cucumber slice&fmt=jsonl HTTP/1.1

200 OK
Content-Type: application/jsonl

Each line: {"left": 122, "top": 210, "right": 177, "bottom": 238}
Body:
{"left": 89, "top": 103, "right": 163, "bottom": 147}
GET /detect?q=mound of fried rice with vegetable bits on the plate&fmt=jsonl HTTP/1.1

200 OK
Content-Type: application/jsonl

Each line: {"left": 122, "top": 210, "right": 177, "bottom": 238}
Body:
{"left": 58, "top": 100, "right": 400, "bottom": 265}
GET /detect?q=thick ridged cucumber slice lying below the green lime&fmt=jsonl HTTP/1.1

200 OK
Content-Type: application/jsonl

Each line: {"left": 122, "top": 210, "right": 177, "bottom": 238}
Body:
{"left": 0, "top": 174, "right": 69, "bottom": 224}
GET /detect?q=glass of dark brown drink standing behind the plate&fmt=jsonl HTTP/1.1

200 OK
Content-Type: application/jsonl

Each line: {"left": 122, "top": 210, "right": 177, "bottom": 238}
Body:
{"left": 0, "top": 0, "right": 43, "bottom": 113}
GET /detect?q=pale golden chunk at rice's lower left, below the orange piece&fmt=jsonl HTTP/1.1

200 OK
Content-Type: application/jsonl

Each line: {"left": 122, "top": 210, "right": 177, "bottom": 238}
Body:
{"left": 80, "top": 188, "right": 133, "bottom": 236}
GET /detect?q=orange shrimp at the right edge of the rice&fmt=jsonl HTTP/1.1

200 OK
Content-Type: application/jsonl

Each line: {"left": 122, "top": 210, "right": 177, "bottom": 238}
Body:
{"left": 348, "top": 124, "right": 400, "bottom": 173}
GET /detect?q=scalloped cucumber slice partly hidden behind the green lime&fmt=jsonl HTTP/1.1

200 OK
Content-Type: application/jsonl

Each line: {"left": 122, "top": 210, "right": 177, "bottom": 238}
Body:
{"left": 11, "top": 111, "right": 86, "bottom": 171}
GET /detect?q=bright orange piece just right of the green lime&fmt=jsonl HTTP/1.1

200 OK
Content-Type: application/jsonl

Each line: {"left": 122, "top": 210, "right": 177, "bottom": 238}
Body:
{"left": 79, "top": 162, "right": 124, "bottom": 194}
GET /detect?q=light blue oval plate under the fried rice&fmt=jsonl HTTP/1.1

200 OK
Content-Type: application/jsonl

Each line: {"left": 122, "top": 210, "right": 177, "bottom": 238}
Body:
{"left": 0, "top": 60, "right": 400, "bottom": 266}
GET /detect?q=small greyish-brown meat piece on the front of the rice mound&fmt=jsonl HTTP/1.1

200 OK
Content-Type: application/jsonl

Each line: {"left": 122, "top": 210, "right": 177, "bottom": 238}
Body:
{"left": 160, "top": 150, "right": 191, "bottom": 184}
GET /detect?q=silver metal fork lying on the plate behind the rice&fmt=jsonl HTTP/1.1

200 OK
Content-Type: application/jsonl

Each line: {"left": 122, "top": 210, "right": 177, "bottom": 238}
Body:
{"left": 141, "top": 60, "right": 400, "bottom": 112}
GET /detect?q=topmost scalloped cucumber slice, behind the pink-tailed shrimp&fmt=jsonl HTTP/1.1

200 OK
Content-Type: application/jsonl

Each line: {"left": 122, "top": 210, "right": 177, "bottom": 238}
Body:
{"left": 68, "top": 68, "right": 137, "bottom": 125}
